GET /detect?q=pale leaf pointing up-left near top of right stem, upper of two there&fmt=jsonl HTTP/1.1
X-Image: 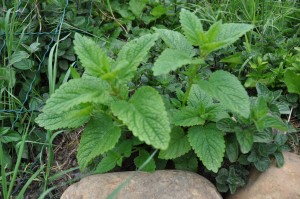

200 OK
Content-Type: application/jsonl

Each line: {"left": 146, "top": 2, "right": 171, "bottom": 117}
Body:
{"left": 155, "top": 29, "right": 195, "bottom": 57}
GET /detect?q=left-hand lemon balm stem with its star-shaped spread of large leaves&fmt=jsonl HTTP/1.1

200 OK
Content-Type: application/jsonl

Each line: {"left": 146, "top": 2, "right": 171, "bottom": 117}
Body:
{"left": 36, "top": 34, "right": 171, "bottom": 168}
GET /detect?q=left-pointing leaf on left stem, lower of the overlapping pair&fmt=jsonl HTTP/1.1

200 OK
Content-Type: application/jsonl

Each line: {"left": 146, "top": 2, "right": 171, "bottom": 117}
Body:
{"left": 35, "top": 103, "right": 93, "bottom": 130}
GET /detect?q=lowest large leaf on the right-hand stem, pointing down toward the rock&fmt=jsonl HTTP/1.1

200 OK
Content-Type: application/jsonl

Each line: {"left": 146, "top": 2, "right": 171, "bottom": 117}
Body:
{"left": 188, "top": 124, "right": 225, "bottom": 173}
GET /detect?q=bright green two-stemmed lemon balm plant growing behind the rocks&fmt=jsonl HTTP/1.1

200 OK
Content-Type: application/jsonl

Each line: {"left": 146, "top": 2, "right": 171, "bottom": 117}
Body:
{"left": 36, "top": 10, "right": 252, "bottom": 172}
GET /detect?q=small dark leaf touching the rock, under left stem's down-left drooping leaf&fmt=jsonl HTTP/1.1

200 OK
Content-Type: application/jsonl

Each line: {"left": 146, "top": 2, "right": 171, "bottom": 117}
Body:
{"left": 96, "top": 151, "right": 121, "bottom": 173}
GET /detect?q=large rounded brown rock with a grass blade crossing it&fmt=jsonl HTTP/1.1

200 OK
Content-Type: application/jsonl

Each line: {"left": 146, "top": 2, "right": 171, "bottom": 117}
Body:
{"left": 61, "top": 171, "right": 222, "bottom": 199}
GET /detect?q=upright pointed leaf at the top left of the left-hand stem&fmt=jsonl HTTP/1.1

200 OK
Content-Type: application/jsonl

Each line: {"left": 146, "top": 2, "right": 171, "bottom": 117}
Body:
{"left": 74, "top": 33, "right": 110, "bottom": 77}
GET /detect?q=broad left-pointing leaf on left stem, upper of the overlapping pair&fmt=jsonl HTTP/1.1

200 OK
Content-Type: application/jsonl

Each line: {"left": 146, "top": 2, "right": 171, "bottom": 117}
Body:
{"left": 39, "top": 77, "right": 112, "bottom": 114}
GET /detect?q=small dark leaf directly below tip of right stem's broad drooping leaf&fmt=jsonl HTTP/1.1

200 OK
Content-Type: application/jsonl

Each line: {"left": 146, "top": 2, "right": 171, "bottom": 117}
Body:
{"left": 235, "top": 128, "right": 254, "bottom": 153}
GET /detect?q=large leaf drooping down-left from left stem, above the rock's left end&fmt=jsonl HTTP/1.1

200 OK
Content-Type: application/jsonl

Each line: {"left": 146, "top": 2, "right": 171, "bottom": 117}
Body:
{"left": 77, "top": 113, "right": 121, "bottom": 169}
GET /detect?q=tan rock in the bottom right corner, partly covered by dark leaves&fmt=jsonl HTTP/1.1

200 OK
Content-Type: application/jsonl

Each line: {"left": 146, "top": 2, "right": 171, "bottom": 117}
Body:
{"left": 228, "top": 152, "right": 300, "bottom": 199}
